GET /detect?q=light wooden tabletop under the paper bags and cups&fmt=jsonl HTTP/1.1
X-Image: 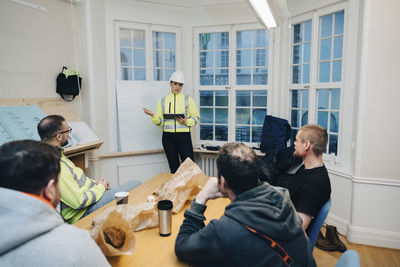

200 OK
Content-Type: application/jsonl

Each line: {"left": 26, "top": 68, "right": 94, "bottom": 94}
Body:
{"left": 74, "top": 173, "right": 230, "bottom": 266}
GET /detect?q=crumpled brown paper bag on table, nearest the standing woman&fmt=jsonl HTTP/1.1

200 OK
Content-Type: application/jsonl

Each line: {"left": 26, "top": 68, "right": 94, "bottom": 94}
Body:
{"left": 153, "top": 158, "right": 208, "bottom": 214}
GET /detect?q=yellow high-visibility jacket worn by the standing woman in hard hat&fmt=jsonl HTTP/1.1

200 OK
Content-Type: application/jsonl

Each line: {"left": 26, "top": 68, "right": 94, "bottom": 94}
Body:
{"left": 151, "top": 93, "right": 200, "bottom": 133}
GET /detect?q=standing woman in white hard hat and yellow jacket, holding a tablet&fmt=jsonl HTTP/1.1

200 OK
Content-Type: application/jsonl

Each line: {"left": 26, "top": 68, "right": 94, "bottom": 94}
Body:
{"left": 143, "top": 71, "right": 200, "bottom": 173}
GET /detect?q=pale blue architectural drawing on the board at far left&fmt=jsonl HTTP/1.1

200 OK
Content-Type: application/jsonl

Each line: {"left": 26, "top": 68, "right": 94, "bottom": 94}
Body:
{"left": 0, "top": 105, "right": 46, "bottom": 145}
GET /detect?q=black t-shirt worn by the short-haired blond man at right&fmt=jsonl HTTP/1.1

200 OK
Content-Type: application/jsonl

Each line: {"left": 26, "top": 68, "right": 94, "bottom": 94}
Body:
{"left": 274, "top": 165, "right": 331, "bottom": 217}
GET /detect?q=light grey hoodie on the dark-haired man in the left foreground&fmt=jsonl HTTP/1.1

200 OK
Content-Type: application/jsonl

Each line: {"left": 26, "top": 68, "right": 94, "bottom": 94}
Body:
{"left": 0, "top": 188, "right": 110, "bottom": 267}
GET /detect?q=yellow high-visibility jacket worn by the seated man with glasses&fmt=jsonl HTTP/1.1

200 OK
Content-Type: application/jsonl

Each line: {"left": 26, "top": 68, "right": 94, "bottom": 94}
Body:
{"left": 59, "top": 152, "right": 106, "bottom": 223}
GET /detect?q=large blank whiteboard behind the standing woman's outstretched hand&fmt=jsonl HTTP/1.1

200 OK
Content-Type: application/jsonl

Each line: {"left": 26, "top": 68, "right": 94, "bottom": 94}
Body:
{"left": 117, "top": 81, "right": 171, "bottom": 152}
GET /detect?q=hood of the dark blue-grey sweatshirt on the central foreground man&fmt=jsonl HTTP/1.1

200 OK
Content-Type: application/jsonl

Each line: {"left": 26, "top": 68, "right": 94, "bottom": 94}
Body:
{"left": 225, "top": 183, "right": 304, "bottom": 241}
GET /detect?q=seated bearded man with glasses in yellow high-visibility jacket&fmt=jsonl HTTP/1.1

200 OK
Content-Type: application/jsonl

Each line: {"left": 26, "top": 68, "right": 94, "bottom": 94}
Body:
{"left": 38, "top": 115, "right": 140, "bottom": 223}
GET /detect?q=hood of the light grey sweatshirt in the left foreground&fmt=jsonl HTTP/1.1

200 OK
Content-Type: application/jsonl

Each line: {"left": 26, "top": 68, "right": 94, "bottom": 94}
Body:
{"left": 0, "top": 188, "right": 64, "bottom": 256}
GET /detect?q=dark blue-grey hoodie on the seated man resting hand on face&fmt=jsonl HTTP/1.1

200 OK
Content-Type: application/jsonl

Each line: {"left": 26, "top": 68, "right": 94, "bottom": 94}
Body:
{"left": 175, "top": 183, "right": 316, "bottom": 267}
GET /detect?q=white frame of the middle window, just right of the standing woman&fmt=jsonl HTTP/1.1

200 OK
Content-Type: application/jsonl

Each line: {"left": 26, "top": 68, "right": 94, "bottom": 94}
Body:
{"left": 193, "top": 23, "right": 276, "bottom": 146}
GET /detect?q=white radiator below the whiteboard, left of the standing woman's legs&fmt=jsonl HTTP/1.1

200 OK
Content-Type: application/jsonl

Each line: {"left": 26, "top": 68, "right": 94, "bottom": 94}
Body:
{"left": 117, "top": 160, "right": 170, "bottom": 185}
